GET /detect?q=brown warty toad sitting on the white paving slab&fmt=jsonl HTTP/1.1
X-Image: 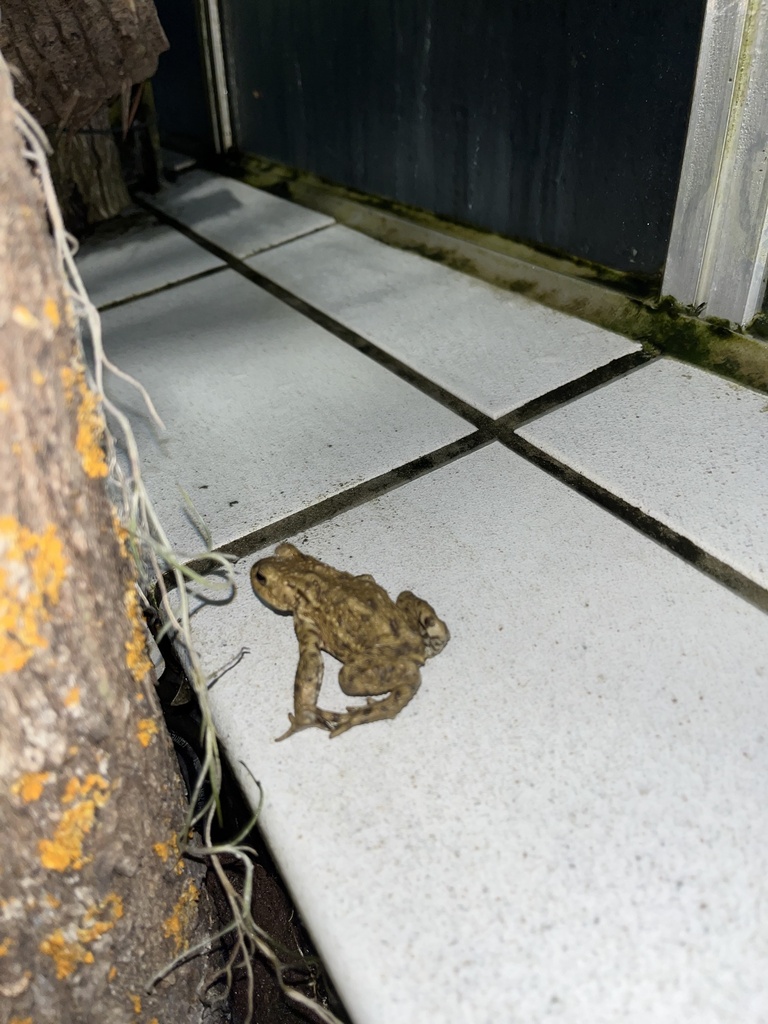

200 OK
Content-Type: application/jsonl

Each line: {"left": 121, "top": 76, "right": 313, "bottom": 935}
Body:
{"left": 251, "top": 544, "right": 451, "bottom": 739}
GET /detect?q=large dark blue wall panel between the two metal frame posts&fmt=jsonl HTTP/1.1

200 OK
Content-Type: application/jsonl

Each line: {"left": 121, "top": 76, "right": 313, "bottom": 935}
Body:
{"left": 223, "top": 0, "right": 705, "bottom": 274}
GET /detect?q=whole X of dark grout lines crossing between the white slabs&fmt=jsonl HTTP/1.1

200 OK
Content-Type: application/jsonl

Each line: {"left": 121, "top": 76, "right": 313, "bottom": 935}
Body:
{"left": 136, "top": 193, "right": 768, "bottom": 612}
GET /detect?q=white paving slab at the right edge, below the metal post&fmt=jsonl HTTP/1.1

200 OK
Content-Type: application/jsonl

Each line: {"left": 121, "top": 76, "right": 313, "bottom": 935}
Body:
{"left": 519, "top": 358, "right": 768, "bottom": 587}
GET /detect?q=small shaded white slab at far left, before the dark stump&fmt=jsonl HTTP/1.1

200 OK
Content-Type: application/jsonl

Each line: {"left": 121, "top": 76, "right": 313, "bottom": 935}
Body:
{"left": 76, "top": 217, "right": 223, "bottom": 306}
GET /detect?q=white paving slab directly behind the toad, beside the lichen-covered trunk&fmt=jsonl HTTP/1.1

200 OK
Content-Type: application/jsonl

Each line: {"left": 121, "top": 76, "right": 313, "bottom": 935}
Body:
{"left": 102, "top": 269, "right": 473, "bottom": 554}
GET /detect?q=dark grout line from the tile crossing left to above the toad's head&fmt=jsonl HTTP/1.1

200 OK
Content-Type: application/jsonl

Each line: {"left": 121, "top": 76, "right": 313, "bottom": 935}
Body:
{"left": 166, "top": 430, "right": 496, "bottom": 587}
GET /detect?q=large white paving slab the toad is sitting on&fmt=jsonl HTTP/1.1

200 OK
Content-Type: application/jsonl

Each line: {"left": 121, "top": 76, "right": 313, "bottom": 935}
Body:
{"left": 194, "top": 444, "right": 768, "bottom": 1024}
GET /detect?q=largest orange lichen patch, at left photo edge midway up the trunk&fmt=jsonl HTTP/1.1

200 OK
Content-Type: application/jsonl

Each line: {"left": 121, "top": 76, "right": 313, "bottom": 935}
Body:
{"left": 0, "top": 516, "right": 68, "bottom": 673}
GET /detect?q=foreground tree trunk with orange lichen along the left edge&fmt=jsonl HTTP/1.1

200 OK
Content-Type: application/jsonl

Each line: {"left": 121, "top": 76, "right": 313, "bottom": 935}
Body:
{"left": 0, "top": 54, "right": 214, "bottom": 1024}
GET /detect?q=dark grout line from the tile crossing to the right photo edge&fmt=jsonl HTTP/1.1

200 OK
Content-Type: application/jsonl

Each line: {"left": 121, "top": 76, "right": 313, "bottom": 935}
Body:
{"left": 497, "top": 429, "right": 768, "bottom": 612}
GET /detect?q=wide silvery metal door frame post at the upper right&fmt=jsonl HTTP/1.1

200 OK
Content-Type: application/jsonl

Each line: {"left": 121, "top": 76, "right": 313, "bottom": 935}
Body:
{"left": 663, "top": 0, "right": 768, "bottom": 326}
